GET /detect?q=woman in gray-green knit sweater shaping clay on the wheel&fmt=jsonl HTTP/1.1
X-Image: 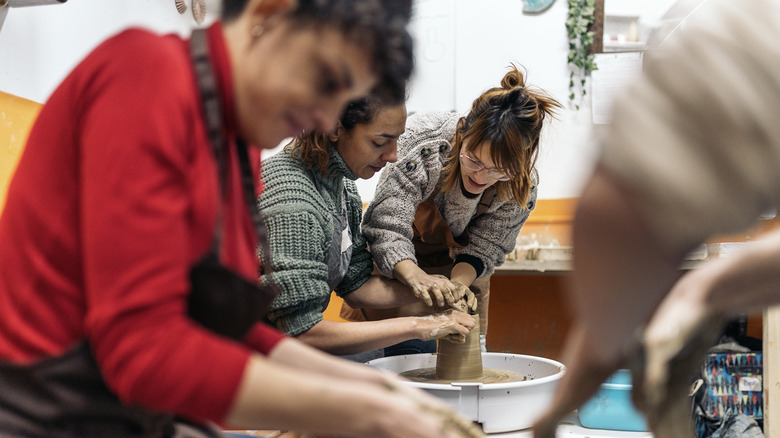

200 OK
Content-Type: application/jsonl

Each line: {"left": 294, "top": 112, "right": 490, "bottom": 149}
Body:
{"left": 258, "top": 97, "right": 475, "bottom": 357}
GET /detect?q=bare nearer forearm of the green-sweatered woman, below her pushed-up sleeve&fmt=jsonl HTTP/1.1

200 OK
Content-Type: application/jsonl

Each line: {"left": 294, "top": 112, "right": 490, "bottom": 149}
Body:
{"left": 296, "top": 317, "right": 425, "bottom": 355}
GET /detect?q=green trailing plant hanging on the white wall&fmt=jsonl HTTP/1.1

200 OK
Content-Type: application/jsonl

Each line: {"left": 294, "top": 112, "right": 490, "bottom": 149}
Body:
{"left": 566, "top": 0, "right": 598, "bottom": 109}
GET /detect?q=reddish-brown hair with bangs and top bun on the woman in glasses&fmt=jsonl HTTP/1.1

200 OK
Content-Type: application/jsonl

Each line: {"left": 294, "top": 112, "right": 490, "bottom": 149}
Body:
{"left": 441, "top": 64, "right": 562, "bottom": 205}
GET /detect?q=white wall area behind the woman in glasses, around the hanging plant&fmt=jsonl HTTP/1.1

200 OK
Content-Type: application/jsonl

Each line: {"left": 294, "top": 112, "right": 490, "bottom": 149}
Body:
{"left": 400, "top": 0, "right": 593, "bottom": 199}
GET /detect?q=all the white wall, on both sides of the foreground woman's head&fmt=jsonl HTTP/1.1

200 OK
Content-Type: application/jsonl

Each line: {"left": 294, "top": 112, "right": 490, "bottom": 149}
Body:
{"left": 0, "top": 0, "right": 668, "bottom": 201}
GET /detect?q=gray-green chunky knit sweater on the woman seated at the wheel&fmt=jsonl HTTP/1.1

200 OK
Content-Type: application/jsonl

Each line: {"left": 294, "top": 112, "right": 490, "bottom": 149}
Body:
{"left": 258, "top": 150, "right": 373, "bottom": 336}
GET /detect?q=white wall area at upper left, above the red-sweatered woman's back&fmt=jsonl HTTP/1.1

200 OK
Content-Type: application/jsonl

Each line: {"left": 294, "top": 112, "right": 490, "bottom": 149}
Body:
{"left": 0, "top": 0, "right": 220, "bottom": 102}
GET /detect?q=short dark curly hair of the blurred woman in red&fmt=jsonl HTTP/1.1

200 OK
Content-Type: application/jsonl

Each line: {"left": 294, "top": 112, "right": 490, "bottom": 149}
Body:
{"left": 222, "top": 0, "right": 414, "bottom": 103}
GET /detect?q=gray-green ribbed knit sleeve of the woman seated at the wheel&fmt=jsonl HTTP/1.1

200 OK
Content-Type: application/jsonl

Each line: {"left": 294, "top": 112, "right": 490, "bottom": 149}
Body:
{"left": 258, "top": 156, "right": 333, "bottom": 336}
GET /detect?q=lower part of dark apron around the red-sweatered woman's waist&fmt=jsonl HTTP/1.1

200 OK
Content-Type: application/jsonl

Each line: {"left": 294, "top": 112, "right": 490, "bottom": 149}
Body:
{"left": 0, "top": 341, "right": 229, "bottom": 438}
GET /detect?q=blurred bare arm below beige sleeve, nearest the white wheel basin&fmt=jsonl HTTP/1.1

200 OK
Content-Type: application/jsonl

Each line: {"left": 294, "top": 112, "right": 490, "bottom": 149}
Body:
{"left": 535, "top": 168, "right": 692, "bottom": 438}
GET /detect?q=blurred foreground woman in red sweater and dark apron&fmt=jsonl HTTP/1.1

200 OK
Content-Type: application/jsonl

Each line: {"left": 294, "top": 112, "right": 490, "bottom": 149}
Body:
{"left": 0, "top": 0, "right": 482, "bottom": 438}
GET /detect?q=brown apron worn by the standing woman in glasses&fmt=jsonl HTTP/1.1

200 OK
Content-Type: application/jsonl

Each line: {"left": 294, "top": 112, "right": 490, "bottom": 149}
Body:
{"left": 341, "top": 186, "right": 496, "bottom": 334}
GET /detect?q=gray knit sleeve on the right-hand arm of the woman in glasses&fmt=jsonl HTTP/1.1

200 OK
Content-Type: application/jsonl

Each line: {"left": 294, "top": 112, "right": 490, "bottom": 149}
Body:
{"left": 452, "top": 172, "right": 538, "bottom": 277}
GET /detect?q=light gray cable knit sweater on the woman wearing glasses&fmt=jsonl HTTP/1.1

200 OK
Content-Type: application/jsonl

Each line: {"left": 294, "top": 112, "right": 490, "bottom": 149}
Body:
{"left": 362, "top": 112, "right": 538, "bottom": 278}
